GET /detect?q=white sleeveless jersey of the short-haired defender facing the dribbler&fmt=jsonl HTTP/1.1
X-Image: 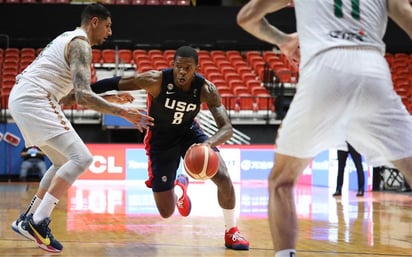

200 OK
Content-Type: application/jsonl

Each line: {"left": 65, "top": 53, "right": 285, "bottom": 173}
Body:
{"left": 17, "top": 28, "right": 87, "bottom": 100}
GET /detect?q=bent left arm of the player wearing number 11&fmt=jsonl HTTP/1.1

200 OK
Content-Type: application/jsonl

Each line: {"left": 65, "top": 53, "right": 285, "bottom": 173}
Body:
{"left": 237, "top": 0, "right": 300, "bottom": 66}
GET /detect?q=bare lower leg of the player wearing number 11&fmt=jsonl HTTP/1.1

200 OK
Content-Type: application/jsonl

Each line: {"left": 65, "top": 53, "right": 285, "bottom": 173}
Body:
{"left": 269, "top": 153, "right": 311, "bottom": 251}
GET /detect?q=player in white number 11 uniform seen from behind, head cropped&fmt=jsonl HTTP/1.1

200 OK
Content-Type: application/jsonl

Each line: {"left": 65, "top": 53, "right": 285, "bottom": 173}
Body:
{"left": 237, "top": 0, "right": 412, "bottom": 257}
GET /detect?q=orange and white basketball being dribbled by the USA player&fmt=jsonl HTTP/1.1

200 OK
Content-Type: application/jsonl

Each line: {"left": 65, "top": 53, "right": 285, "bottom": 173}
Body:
{"left": 183, "top": 144, "right": 219, "bottom": 180}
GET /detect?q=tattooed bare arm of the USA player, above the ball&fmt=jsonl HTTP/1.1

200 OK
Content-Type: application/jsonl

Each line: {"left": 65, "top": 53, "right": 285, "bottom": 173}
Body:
{"left": 200, "top": 80, "right": 233, "bottom": 147}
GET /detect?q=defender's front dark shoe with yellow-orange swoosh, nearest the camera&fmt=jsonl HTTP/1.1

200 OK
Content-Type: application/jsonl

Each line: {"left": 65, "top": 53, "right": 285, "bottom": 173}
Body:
{"left": 26, "top": 214, "right": 63, "bottom": 253}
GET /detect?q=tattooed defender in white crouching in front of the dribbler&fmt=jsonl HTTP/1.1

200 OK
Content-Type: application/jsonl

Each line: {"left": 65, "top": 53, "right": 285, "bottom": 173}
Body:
{"left": 9, "top": 4, "right": 152, "bottom": 252}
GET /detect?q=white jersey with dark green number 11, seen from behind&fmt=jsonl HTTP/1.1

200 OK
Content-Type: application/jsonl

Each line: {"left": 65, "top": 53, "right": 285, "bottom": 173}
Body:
{"left": 293, "top": 0, "right": 388, "bottom": 67}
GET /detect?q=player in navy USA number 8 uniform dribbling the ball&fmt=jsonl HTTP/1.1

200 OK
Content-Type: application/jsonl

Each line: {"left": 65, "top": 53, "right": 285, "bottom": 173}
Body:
{"left": 92, "top": 46, "right": 249, "bottom": 250}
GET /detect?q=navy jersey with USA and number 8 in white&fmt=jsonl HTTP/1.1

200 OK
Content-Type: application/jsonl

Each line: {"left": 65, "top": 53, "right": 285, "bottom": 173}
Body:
{"left": 145, "top": 68, "right": 205, "bottom": 146}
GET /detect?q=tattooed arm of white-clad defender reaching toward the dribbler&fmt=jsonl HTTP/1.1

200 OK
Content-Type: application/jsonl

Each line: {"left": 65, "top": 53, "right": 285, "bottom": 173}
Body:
{"left": 67, "top": 38, "right": 153, "bottom": 131}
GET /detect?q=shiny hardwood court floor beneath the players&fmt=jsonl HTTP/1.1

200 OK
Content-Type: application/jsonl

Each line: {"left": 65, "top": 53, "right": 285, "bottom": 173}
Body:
{"left": 0, "top": 181, "right": 412, "bottom": 257}
